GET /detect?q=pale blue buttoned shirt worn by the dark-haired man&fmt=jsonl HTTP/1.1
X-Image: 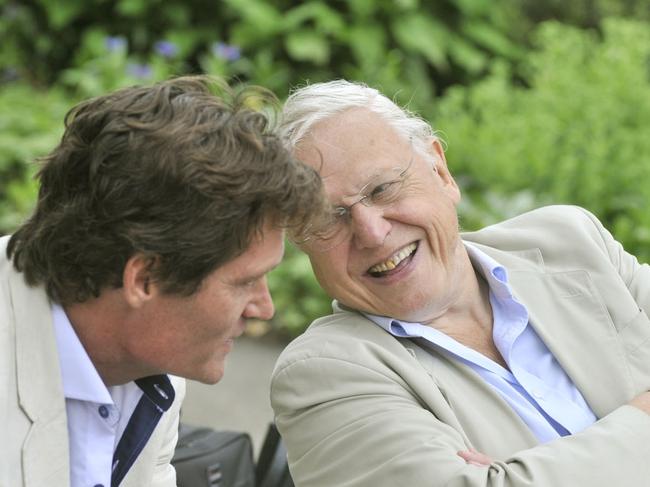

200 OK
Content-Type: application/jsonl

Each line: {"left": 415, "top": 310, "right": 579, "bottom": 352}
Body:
{"left": 52, "top": 304, "right": 143, "bottom": 487}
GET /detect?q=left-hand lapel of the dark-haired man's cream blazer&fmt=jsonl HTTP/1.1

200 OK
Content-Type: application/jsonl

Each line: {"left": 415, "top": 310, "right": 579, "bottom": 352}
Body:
{"left": 9, "top": 272, "right": 70, "bottom": 487}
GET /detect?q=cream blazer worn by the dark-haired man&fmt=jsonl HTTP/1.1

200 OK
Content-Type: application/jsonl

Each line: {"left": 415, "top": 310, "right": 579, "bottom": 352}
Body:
{"left": 0, "top": 237, "right": 185, "bottom": 487}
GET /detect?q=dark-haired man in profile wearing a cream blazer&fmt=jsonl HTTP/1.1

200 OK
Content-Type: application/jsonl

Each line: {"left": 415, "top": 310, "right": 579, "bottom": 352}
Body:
{"left": 0, "top": 77, "right": 322, "bottom": 487}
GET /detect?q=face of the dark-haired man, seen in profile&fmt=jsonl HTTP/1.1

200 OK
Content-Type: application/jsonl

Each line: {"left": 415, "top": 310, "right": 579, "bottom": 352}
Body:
{"left": 128, "top": 223, "right": 284, "bottom": 384}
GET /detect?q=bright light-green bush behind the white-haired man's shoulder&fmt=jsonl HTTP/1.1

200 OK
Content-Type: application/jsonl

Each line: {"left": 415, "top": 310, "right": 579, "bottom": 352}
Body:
{"left": 435, "top": 20, "right": 650, "bottom": 261}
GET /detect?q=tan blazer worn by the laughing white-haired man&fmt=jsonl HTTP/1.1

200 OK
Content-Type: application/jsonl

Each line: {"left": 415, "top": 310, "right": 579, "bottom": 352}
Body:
{"left": 271, "top": 206, "right": 650, "bottom": 487}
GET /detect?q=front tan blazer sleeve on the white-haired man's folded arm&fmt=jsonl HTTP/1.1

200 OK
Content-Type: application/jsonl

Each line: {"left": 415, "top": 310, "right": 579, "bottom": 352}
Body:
{"left": 271, "top": 350, "right": 650, "bottom": 487}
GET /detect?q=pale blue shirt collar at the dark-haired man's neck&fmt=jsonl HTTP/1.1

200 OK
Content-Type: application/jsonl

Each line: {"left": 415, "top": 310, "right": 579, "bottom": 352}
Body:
{"left": 52, "top": 303, "right": 113, "bottom": 404}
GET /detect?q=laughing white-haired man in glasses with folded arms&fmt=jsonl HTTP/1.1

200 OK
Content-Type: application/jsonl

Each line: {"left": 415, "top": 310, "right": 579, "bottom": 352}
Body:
{"left": 271, "top": 81, "right": 650, "bottom": 487}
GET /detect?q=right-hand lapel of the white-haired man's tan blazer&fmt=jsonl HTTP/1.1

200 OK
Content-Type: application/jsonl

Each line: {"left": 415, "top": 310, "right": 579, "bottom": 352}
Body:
{"left": 480, "top": 246, "right": 633, "bottom": 417}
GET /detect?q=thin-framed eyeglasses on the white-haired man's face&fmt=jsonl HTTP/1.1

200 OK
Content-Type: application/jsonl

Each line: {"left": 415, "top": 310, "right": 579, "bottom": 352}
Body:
{"left": 297, "top": 152, "right": 413, "bottom": 251}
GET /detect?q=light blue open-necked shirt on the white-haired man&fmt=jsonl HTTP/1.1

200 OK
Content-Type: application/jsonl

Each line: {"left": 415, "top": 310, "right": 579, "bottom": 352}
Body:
{"left": 366, "top": 242, "right": 596, "bottom": 443}
